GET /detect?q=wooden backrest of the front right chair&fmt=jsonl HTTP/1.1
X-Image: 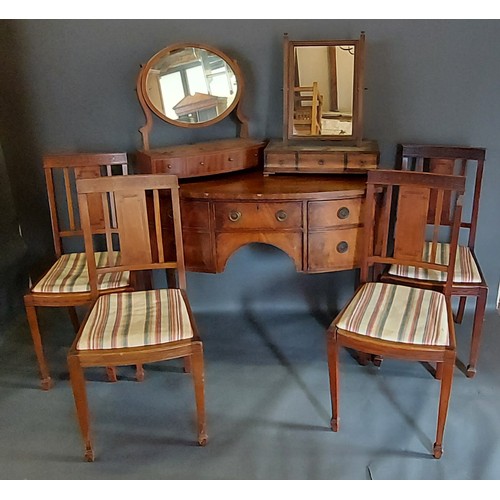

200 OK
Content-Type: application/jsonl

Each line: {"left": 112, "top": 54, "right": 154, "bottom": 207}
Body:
{"left": 361, "top": 170, "right": 466, "bottom": 293}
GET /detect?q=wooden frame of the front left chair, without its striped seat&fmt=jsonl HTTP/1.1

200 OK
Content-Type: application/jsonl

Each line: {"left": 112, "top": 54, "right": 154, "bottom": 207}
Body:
{"left": 68, "top": 174, "right": 207, "bottom": 461}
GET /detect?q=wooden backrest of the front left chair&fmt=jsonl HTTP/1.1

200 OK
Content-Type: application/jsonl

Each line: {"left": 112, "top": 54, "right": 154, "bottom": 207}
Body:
{"left": 76, "top": 174, "right": 186, "bottom": 295}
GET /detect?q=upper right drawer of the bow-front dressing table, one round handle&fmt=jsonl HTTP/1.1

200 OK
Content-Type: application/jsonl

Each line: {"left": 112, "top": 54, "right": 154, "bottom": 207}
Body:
{"left": 308, "top": 198, "right": 363, "bottom": 229}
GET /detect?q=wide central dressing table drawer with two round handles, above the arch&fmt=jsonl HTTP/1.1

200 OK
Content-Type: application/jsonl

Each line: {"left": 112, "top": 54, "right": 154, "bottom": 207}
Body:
{"left": 215, "top": 202, "right": 302, "bottom": 230}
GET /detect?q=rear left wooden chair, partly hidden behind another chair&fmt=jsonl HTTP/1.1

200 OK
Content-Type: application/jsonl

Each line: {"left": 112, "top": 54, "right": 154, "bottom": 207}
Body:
{"left": 24, "top": 153, "right": 129, "bottom": 390}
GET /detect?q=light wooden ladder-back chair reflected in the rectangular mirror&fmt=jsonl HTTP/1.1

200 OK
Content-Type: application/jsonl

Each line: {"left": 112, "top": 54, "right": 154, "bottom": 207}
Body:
{"left": 293, "top": 82, "right": 323, "bottom": 135}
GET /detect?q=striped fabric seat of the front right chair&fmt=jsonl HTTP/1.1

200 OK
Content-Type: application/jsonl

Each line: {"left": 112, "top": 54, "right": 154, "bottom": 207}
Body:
{"left": 337, "top": 283, "right": 449, "bottom": 346}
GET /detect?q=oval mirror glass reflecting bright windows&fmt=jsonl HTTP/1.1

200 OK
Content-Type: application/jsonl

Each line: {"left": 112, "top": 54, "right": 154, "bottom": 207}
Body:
{"left": 142, "top": 45, "right": 240, "bottom": 126}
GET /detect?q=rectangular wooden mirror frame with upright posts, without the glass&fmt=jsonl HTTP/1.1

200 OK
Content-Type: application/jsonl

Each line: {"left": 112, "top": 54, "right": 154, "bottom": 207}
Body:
{"left": 283, "top": 31, "right": 365, "bottom": 145}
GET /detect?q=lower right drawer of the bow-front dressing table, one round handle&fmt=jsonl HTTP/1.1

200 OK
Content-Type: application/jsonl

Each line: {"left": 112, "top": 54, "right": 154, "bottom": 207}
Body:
{"left": 307, "top": 227, "right": 363, "bottom": 272}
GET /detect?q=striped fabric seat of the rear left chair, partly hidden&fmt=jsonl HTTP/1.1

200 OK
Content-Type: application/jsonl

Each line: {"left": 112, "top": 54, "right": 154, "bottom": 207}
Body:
{"left": 33, "top": 252, "right": 130, "bottom": 293}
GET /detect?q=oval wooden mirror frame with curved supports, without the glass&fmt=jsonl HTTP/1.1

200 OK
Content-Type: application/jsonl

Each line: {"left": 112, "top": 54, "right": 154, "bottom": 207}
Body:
{"left": 136, "top": 42, "right": 248, "bottom": 150}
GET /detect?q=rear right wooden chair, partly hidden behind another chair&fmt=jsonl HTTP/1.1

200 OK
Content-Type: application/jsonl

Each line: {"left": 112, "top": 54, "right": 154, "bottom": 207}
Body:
{"left": 384, "top": 144, "right": 488, "bottom": 377}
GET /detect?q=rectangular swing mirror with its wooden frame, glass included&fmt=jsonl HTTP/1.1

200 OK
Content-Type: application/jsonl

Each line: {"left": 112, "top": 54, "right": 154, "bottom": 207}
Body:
{"left": 283, "top": 32, "right": 365, "bottom": 144}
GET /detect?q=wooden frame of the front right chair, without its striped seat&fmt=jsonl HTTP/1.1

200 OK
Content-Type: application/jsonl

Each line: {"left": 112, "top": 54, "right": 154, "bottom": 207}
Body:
{"left": 327, "top": 171, "right": 465, "bottom": 458}
